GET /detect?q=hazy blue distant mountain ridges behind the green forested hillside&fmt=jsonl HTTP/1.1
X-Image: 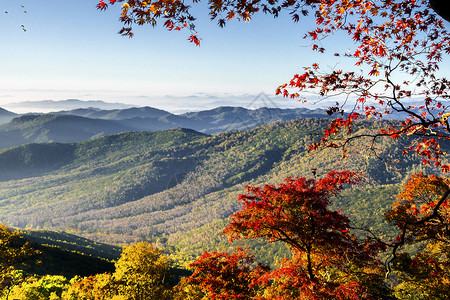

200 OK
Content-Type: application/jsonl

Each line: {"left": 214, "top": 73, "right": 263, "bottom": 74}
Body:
{"left": 0, "top": 106, "right": 336, "bottom": 149}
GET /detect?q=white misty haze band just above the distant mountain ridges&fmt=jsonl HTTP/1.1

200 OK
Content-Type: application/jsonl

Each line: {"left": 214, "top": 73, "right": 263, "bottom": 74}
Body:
{"left": 0, "top": 89, "right": 334, "bottom": 113}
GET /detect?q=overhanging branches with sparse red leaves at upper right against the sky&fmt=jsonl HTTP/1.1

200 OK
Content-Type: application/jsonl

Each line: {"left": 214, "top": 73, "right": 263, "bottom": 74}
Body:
{"left": 276, "top": 0, "right": 450, "bottom": 172}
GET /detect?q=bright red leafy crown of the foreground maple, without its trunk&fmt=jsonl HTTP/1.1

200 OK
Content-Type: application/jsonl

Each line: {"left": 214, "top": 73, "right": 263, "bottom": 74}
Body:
{"left": 224, "top": 171, "right": 358, "bottom": 251}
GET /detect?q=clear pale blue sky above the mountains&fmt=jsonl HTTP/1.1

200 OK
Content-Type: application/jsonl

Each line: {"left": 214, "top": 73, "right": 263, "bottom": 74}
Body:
{"left": 0, "top": 0, "right": 448, "bottom": 112}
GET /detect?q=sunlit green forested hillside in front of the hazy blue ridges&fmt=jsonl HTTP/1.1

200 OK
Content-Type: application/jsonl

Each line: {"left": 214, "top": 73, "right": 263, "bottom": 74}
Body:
{"left": 0, "top": 118, "right": 442, "bottom": 259}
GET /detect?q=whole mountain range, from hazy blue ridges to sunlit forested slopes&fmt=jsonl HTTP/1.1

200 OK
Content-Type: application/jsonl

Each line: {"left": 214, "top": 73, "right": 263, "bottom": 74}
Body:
{"left": 0, "top": 101, "right": 450, "bottom": 266}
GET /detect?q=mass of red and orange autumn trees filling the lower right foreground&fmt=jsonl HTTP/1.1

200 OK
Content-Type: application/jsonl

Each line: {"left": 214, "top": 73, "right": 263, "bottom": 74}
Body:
{"left": 182, "top": 171, "right": 450, "bottom": 299}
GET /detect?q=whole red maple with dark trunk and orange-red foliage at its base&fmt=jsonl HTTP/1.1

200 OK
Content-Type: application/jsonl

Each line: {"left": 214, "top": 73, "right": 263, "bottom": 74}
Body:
{"left": 224, "top": 171, "right": 386, "bottom": 299}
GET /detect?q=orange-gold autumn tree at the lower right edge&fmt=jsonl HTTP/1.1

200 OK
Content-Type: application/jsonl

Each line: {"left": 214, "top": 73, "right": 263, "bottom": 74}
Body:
{"left": 385, "top": 173, "right": 450, "bottom": 299}
